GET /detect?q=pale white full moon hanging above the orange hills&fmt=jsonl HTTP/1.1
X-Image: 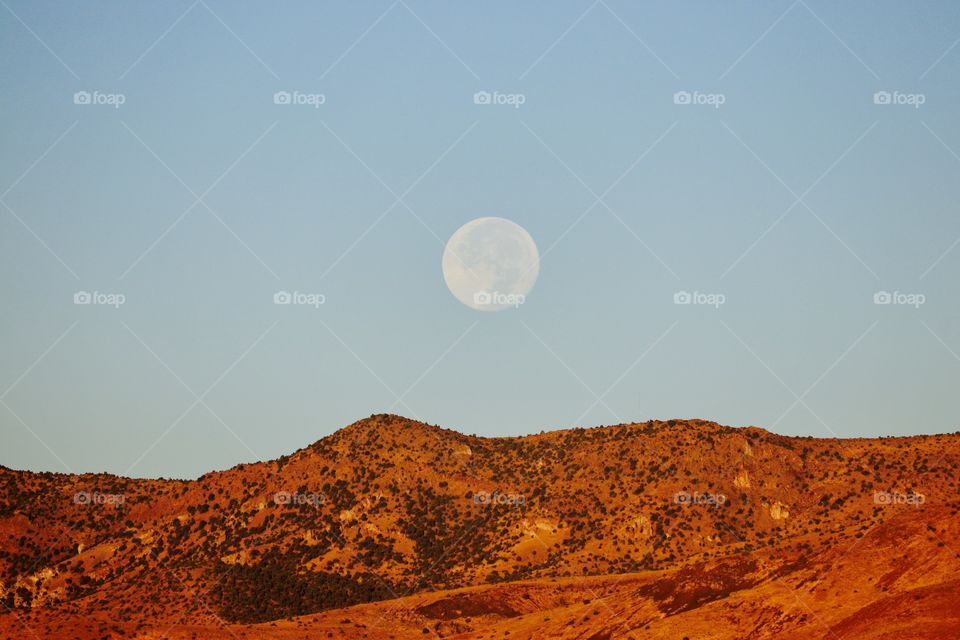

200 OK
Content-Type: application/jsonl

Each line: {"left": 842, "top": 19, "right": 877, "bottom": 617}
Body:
{"left": 443, "top": 218, "right": 540, "bottom": 311}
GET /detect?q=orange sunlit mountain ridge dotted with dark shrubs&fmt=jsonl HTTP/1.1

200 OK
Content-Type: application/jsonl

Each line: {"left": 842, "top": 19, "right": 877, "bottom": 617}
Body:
{"left": 0, "top": 415, "right": 960, "bottom": 640}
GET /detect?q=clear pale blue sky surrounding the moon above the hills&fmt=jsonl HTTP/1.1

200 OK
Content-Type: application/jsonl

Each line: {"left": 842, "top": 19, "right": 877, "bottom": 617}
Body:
{"left": 0, "top": 0, "right": 960, "bottom": 478}
